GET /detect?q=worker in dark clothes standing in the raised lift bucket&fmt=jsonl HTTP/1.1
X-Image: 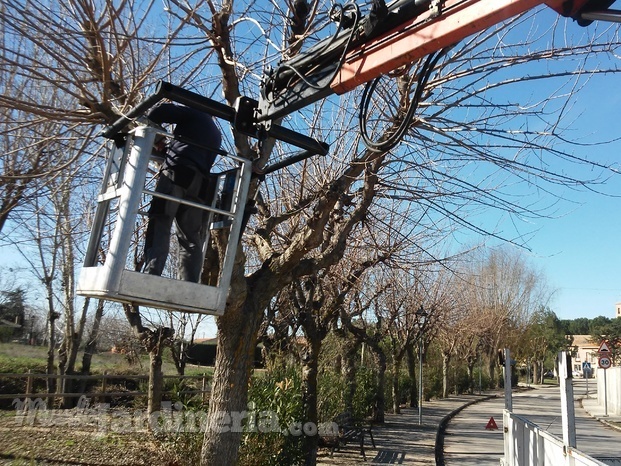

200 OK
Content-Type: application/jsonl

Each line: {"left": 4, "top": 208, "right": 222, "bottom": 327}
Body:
{"left": 144, "top": 103, "right": 222, "bottom": 283}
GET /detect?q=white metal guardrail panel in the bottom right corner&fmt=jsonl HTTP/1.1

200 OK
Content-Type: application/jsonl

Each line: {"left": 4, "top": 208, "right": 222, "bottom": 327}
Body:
{"left": 500, "top": 409, "right": 621, "bottom": 466}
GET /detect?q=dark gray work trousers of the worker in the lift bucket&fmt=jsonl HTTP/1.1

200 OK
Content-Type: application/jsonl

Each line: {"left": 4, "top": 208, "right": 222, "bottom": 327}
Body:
{"left": 144, "top": 170, "right": 207, "bottom": 283}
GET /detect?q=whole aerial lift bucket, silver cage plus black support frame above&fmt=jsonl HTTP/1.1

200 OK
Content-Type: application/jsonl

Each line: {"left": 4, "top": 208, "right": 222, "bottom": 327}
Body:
{"left": 77, "top": 81, "right": 328, "bottom": 315}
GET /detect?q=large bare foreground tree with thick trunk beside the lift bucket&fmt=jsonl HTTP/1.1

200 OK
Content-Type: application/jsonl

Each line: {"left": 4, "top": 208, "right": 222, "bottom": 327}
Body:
{"left": 0, "top": 0, "right": 619, "bottom": 464}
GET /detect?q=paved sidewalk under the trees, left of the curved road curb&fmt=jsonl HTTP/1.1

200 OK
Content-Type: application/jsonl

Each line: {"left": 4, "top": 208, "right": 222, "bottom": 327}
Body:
{"left": 317, "top": 395, "right": 494, "bottom": 466}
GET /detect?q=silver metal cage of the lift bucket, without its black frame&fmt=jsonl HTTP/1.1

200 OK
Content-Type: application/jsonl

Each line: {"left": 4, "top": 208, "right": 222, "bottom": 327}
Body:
{"left": 77, "top": 126, "right": 251, "bottom": 315}
